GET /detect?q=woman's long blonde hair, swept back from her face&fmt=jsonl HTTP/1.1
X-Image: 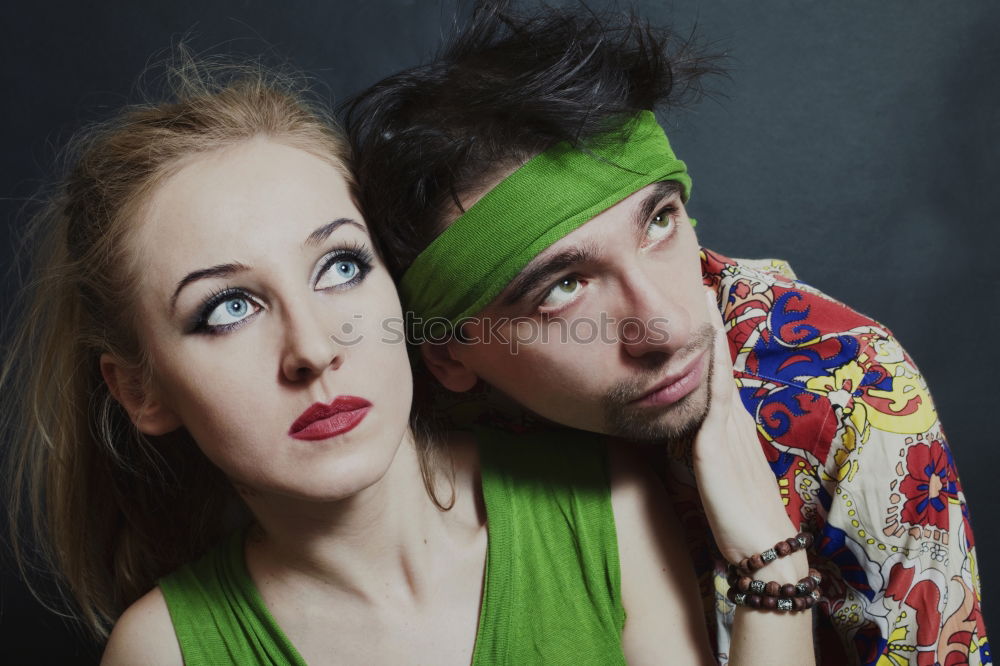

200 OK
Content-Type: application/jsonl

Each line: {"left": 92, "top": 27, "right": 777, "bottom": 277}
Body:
{"left": 0, "top": 49, "right": 360, "bottom": 637}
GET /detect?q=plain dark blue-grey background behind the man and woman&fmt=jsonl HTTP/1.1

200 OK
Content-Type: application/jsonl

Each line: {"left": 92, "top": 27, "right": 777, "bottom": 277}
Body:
{"left": 0, "top": 0, "right": 1000, "bottom": 664}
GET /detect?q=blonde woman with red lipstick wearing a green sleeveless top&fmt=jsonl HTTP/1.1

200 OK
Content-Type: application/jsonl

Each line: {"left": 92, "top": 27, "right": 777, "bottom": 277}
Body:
{"left": 3, "top": 63, "right": 711, "bottom": 666}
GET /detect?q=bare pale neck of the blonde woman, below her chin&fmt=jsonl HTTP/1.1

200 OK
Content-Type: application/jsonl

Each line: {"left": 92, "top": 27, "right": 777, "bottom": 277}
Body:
{"left": 240, "top": 432, "right": 481, "bottom": 601}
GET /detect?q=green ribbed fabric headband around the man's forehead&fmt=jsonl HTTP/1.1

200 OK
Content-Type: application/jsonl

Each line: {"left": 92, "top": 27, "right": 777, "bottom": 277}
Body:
{"left": 399, "top": 111, "right": 691, "bottom": 326}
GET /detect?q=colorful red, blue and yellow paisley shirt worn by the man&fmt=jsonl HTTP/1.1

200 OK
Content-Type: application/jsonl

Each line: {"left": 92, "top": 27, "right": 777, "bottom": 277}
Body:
{"left": 417, "top": 249, "right": 993, "bottom": 666}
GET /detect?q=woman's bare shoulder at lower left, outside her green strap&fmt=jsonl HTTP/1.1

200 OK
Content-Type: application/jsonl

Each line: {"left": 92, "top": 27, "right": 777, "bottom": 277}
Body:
{"left": 101, "top": 587, "right": 184, "bottom": 666}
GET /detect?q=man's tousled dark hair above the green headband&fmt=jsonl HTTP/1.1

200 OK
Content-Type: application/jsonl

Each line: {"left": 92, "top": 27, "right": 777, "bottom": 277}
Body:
{"left": 345, "top": 0, "right": 720, "bottom": 279}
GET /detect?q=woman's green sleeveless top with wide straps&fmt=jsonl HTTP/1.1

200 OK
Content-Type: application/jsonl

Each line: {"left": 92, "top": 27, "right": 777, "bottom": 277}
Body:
{"left": 160, "top": 429, "right": 625, "bottom": 666}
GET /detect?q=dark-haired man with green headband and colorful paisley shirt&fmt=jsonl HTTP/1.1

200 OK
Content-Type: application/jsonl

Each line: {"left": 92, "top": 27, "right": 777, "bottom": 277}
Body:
{"left": 349, "top": 2, "right": 989, "bottom": 664}
